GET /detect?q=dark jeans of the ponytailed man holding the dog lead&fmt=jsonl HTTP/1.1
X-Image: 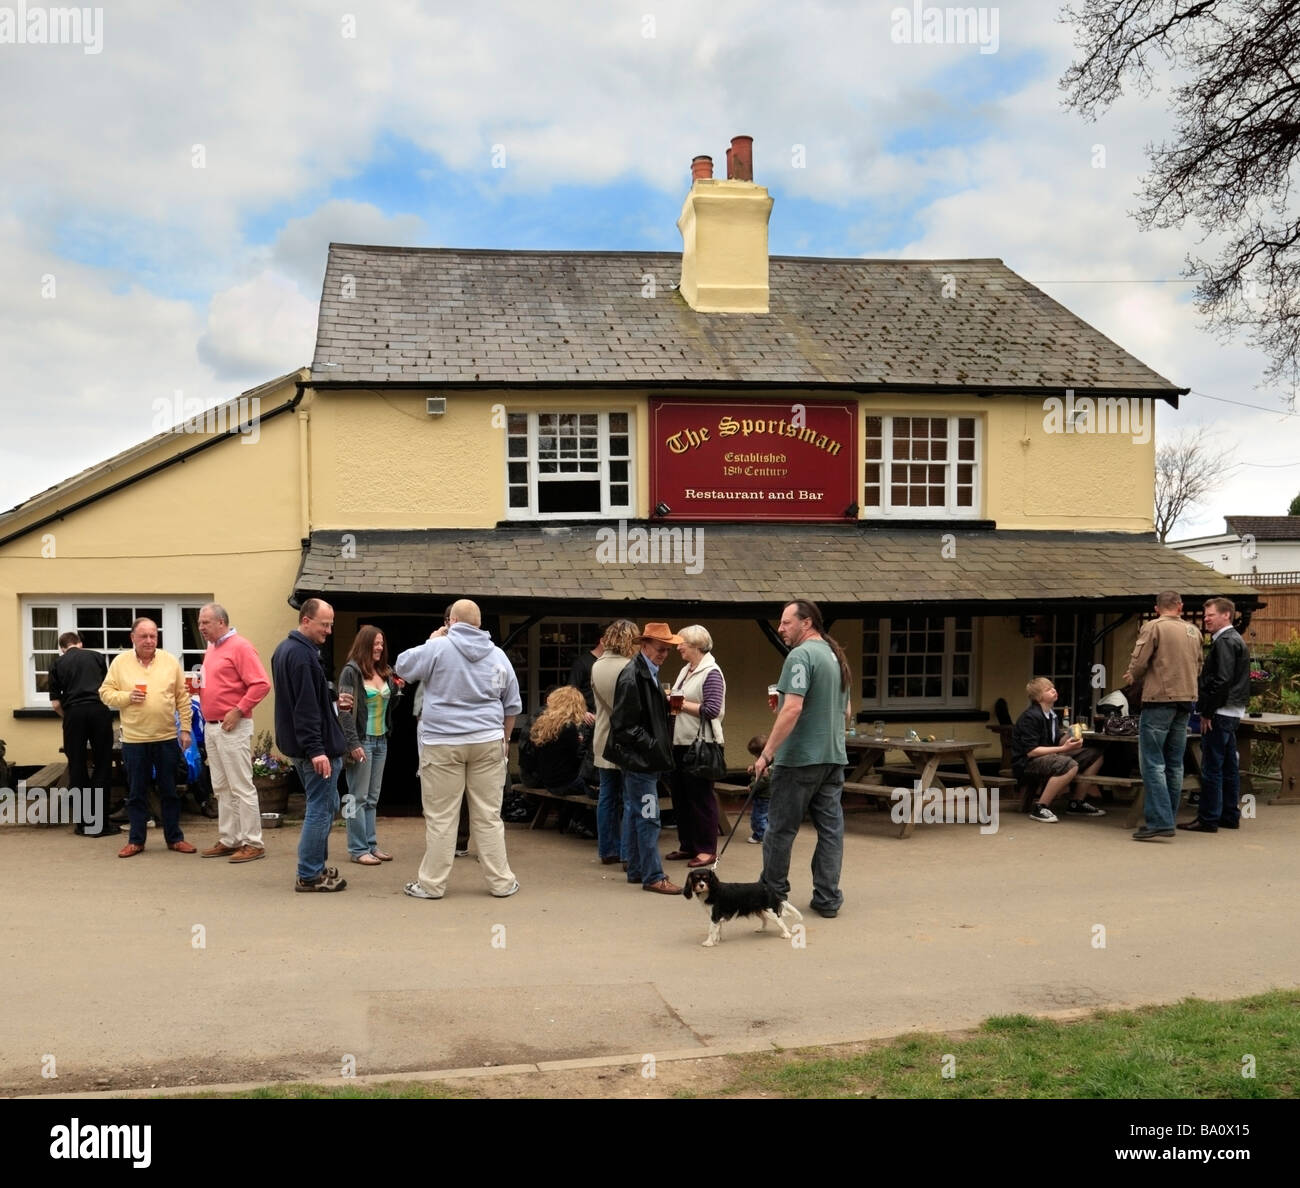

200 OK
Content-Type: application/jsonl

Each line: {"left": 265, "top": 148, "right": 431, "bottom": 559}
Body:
{"left": 763, "top": 763, "right": 844, "bottom": 909}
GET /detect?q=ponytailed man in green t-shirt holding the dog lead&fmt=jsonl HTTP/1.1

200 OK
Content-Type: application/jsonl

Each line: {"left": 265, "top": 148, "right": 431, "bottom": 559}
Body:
{"left": 754, "top": 598, "right": 850, "bottom": 919}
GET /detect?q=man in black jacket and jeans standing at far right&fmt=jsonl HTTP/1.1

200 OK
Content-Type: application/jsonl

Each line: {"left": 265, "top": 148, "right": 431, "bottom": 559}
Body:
{"left": 1178, "top": 598, "right": 1251, "bottom": 833}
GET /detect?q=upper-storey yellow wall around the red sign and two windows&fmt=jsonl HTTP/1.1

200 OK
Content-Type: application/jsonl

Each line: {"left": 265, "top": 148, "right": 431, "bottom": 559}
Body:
{"left": 307, "top": 389, "right": 1156, "bottom": 533}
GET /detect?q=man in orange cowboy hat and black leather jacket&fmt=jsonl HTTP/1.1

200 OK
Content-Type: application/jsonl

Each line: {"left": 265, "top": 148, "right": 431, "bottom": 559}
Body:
{"left": 605, "top": 623, "right": 681, "bottom": 896}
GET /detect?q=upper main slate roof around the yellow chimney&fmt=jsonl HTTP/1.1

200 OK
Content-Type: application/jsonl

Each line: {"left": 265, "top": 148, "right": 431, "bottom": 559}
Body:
{"left": 312, "top": 243, "right": 1187, "bottom": 404}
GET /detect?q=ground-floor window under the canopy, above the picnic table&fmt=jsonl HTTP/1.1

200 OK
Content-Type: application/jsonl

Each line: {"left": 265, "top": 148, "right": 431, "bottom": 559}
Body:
{"left": 862, "top": 615, "right": 975, "bottom": 710}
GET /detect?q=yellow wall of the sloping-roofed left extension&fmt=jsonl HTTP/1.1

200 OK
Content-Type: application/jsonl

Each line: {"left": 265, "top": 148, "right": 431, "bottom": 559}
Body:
{"left": 0, "top": 374, "right": 302, "bottom": 764}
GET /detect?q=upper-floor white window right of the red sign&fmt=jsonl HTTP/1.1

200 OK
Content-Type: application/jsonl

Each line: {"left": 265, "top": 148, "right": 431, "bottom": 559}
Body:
{"left": 862, "top": 416, "right": 983, "bottom": 519}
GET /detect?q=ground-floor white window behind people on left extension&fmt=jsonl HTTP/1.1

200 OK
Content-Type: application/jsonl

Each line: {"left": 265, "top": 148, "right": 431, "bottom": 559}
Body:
{"left": 22, "top": 594, "right": 212, "bottom": 708}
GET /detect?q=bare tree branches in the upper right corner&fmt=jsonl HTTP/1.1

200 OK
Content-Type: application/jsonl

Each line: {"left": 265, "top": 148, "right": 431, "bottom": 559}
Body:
{"left": 1061, "top": 0, "right": 1300, "bottom": 385}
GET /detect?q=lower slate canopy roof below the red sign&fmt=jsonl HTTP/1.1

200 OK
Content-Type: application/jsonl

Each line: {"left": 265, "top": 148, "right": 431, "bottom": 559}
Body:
{"left": 295, "top": 521, "right": 1255, "bottom": 613}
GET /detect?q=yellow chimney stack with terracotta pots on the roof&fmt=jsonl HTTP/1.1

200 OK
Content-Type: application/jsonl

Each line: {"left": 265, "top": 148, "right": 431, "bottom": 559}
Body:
{"left": 677, "top": 136, "right": 772, "bottom": 313}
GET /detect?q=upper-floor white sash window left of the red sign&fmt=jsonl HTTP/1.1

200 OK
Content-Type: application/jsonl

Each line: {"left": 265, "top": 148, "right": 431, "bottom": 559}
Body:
{"left": 506, "top": 412, "right": 636, "bottom": 520}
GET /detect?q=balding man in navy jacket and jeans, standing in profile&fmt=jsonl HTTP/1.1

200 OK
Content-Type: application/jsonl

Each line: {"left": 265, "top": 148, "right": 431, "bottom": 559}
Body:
{"left": 270, "top": 598, "right": 351, "bottom": 892}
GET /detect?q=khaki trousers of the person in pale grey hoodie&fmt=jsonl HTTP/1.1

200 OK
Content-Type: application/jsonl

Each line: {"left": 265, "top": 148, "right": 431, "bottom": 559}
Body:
{"left": 417, "top": 738, "right": 515, "bottom": 896}
